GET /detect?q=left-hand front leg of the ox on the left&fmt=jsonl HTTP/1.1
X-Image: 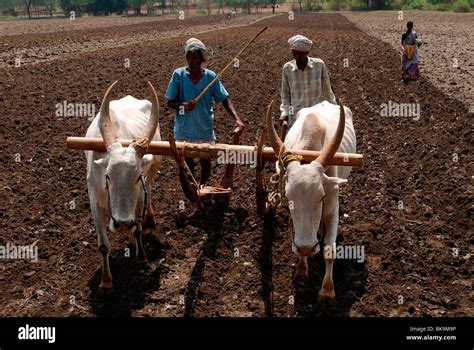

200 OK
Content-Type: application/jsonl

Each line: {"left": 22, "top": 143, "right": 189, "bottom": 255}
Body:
{"left": 92, "top": 204, "right": 112, "bottom": 290}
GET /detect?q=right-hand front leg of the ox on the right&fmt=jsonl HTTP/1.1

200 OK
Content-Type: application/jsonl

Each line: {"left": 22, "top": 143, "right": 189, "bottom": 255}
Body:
{"left": 319, "top": 215, "right": 338, "bottom": 304}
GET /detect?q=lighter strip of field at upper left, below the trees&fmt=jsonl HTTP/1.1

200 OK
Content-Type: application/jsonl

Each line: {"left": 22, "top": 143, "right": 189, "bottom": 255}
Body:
{"left": 0, "top": 13, "right": 271, "bottom": 67}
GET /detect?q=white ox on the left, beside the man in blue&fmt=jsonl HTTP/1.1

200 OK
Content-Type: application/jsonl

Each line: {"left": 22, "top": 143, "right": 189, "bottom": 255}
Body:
{"left": 85, "top": 82, "right": 161, "bottom": 289}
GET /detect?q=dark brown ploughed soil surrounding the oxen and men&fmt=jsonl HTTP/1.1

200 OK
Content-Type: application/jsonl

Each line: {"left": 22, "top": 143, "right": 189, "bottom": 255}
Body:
{"left": 0, "top": 14, "right": 474, "bottom": 317}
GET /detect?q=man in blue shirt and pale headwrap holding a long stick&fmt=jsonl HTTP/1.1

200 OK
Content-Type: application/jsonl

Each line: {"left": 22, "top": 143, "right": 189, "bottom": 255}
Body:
{"left": 165, "top": 38, "right": 244, "bottom": 185}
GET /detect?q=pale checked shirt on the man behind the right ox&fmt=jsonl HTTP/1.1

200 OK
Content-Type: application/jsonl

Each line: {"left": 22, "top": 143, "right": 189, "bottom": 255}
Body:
{"left": 280, "top": 57, "right": 336, "bottom": 126}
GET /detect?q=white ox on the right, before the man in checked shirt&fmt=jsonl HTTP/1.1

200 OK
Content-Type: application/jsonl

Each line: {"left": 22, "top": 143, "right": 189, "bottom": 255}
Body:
{"left": 267, "top": 101, "right": 356, "bottom": 304}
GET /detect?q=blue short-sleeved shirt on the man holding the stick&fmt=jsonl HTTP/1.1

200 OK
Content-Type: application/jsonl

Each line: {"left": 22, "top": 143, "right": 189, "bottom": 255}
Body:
{"left": 165, "top": 67, "right": 229, "bottom": 141}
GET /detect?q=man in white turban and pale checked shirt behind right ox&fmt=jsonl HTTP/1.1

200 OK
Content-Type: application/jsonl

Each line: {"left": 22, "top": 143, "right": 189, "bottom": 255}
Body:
{"left": 280, "top": 35, "right": 336, "bottom": 127}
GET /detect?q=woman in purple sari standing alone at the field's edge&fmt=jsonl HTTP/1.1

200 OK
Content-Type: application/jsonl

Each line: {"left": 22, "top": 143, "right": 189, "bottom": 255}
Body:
{"left": 402, "top": 21, "right": 421, "bottom": 82}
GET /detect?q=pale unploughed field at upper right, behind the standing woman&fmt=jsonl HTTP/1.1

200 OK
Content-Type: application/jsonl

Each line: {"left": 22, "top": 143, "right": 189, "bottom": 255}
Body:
{"left": 344, "top": 11, "right": 474, "bottom": 113}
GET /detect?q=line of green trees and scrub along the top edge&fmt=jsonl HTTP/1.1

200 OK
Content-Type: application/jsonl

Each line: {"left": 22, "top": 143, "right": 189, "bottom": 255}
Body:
{"left": 0, "top": 0, "right": 474, "bottom": 18}
